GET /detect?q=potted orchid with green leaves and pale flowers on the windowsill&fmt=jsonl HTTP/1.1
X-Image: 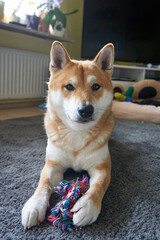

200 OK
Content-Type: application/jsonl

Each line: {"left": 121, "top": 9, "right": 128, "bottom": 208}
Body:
{"left": 38, "top": 0, "right": 78, "bottom": 36}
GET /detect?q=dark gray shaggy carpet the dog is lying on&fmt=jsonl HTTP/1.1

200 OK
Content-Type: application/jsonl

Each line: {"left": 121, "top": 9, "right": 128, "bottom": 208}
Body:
{"left": 0, "top": 117, "right": 160, "bottom": 240}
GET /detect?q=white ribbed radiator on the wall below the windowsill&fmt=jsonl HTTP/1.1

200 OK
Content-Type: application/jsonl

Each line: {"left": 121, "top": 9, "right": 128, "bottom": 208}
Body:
{"left": 0, "top": 47, "right": 49, "bottom": 99}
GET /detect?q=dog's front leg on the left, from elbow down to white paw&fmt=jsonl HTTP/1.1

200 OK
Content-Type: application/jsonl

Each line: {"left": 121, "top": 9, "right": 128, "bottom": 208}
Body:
{"left": 22, "top": 158, "right": 64, "bottom": 229}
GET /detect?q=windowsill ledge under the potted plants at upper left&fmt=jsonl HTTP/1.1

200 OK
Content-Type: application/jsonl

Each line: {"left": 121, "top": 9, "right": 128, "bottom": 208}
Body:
{"left": 0, "top": 22, "right": 74, "bottom": 43}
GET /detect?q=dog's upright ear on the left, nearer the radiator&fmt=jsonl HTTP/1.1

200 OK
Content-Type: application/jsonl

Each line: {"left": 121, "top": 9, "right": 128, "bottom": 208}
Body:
{"left": 50, "top": 41, "right": 71, "bottom": 70}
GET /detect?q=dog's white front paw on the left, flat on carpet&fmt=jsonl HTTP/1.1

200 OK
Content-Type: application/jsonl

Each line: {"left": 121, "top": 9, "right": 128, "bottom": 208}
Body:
{"left": 22, "top": 196, "right": 48, "bottom": 229}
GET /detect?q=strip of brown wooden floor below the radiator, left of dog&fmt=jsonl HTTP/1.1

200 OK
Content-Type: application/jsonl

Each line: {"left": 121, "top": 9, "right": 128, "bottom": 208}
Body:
{"left": 0, "top": 107, "right": 45, "bottom": 120}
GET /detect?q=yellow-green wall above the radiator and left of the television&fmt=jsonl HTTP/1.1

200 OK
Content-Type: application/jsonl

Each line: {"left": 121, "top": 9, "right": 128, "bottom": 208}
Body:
{"left": 0, "top": 0, "right": 83, "bottom": 59}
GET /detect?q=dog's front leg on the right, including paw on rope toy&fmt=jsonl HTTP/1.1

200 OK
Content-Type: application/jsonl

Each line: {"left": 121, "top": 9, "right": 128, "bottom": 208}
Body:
{"left": 72, "top": 156, "right": 111, "bottom": 226}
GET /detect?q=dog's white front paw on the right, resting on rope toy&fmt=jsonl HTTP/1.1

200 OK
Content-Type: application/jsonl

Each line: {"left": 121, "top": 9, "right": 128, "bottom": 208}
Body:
{"left": 71, "top": 193, "right": 101, "bottom": 226}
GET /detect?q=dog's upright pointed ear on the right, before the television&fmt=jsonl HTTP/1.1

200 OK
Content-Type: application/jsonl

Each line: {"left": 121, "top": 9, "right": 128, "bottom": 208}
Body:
{"left": 93, "top": 43, "right": 114, "bottom": 72}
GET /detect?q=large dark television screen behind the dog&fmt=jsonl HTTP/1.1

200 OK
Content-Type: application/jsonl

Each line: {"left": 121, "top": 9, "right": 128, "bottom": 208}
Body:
{"left": 82, "top": 0, "right": 160, "bottom": 64}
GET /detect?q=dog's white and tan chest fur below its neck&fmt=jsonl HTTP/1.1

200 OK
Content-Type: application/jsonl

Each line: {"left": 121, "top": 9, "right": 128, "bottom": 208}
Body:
{"left": 47, "top": 123, "right": 108, "bottom": 171}
